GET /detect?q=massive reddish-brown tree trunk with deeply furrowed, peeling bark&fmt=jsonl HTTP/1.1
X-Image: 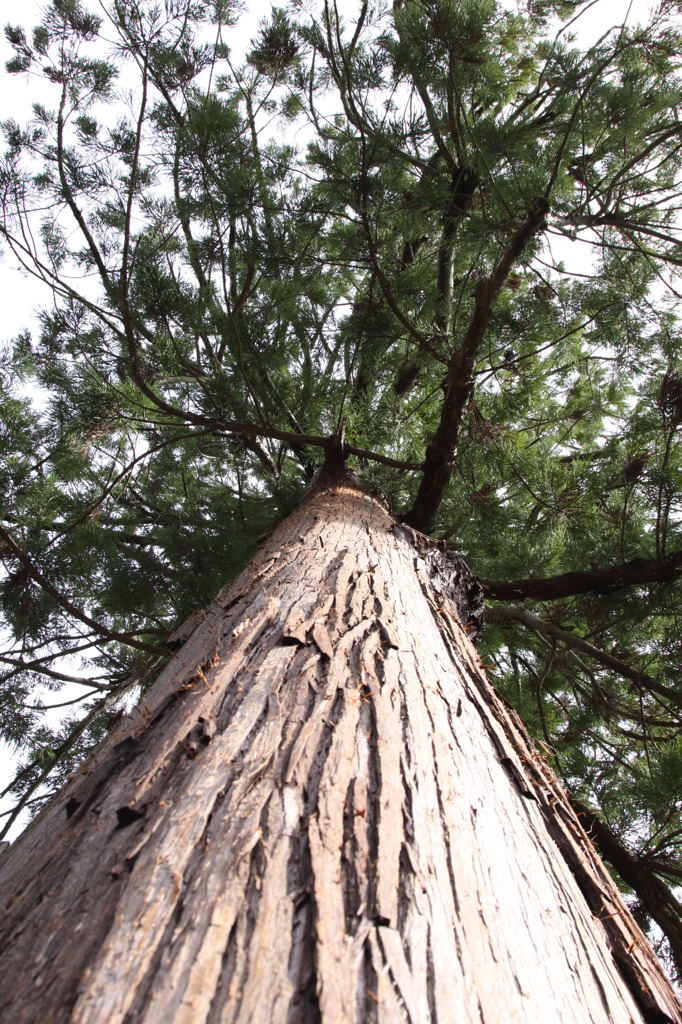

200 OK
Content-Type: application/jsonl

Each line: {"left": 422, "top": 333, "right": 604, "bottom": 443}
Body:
{"left": 0, "top": 483, "right": 682, "bottom": 1024}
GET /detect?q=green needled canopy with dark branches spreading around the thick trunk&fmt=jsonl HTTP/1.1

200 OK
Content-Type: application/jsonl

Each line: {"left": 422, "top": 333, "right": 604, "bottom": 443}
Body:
{"left": 0, "top": 0, "right": 682, "bottom": 973}
